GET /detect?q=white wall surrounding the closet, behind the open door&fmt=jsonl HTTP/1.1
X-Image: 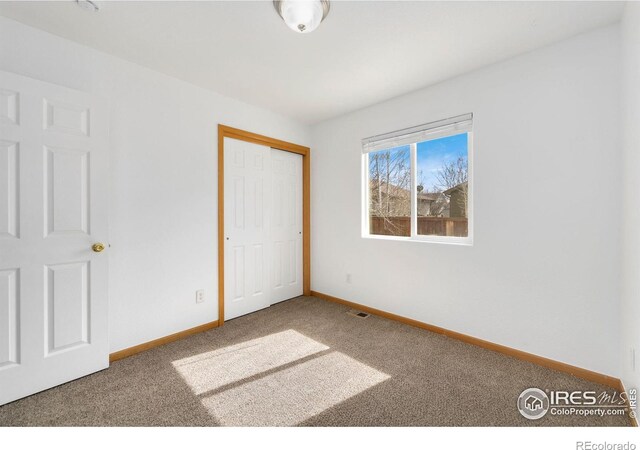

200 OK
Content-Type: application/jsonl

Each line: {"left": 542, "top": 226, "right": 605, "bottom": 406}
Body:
{"left": 0, "top": 18, "right": 309, "bottom": 351}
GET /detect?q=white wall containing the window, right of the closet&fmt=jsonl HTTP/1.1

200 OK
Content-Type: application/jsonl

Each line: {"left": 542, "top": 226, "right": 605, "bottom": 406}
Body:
{"left": 312, "top": 27, "right": 621, "bottom": 375}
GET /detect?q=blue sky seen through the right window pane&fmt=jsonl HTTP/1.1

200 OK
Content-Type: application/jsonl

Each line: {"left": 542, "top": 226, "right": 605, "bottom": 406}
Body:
{"left": 416, "top": 133, "right": 467, "bottom": 191}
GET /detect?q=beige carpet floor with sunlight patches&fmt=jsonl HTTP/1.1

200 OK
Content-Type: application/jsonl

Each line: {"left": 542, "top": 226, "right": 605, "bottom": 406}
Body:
{"left": 0, "top": 297, "right": 629, "bottom": 426}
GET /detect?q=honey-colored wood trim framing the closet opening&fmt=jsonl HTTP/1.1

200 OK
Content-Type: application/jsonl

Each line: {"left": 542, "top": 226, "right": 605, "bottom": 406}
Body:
{"left": 218, "top": 124, "right": 311, "bottom": 326}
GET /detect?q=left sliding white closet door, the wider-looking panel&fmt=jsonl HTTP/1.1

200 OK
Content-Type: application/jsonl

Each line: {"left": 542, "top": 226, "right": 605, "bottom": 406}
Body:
{"left": 224, "top": 138, "right": 271, "bottom": 320}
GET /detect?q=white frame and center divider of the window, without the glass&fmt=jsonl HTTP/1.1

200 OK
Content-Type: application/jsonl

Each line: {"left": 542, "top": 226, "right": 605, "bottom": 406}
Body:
{"left": 361, "top": 116, "right": 474, "bottom": 246}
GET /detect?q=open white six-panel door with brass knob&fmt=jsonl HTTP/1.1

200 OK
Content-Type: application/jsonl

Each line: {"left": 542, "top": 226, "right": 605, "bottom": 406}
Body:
{"left": 0, "top": 72, "right": 109, "bottom": 404}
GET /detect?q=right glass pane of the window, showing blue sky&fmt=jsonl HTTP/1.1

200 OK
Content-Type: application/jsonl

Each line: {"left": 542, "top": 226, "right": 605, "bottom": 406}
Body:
{"left": 416, "top": 133, "right": 469, "bottom": 237}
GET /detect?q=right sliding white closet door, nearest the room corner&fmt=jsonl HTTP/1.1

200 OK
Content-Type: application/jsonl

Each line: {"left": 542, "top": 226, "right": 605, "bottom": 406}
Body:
{"left": 270, "top": 149, "right": 302, "bottom": 304}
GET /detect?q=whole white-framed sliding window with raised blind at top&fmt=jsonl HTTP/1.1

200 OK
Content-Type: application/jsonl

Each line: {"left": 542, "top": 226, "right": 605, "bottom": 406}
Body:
{"left": 363, "top": 114, "right": 472, "bottom": 244}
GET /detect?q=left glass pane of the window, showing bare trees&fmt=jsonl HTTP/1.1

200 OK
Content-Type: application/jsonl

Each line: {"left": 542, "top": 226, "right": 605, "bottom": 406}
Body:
{"left": 369, "top": 145, "right": 411, "bottom": 236}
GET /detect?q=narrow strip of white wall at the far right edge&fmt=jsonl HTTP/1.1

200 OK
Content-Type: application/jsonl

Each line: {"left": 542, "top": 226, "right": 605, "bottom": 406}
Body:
{"left": 620, "top": 2, "right": 640, "bottom": 388}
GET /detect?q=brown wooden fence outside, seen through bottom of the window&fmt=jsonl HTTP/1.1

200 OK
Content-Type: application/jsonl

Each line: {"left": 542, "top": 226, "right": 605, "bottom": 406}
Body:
{"left": 369, "top": 216, "right": 468, "bottom": 237}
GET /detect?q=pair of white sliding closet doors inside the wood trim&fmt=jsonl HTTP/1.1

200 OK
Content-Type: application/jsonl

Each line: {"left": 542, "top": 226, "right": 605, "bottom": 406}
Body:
{"left": 224, "top": 138, "right": 302, "bottom": 320}
